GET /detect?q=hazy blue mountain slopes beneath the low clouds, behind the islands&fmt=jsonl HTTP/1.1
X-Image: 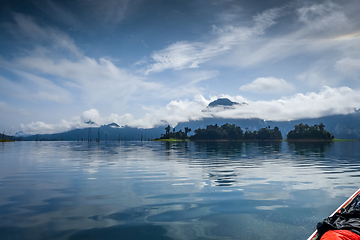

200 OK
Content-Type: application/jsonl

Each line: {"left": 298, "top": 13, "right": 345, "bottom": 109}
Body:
{"left": 22, "top": 112, "right": 360, "bottom": 141}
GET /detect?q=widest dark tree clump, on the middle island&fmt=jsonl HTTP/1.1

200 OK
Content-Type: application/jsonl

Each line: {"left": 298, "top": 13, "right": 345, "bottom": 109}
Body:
{"left": 190, "top": 123, "right": 282, "bottom": 141}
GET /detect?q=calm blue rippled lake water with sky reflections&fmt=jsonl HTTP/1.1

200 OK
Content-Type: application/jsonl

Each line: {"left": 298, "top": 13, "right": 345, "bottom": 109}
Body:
{"left": 0, "top": 142, "right": 360, "bottom": 240}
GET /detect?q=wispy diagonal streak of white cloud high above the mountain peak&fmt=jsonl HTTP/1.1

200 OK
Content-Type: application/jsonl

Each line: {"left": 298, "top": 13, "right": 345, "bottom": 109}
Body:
{"left": 144, "top": 8, "right": 283, "bottom": 75}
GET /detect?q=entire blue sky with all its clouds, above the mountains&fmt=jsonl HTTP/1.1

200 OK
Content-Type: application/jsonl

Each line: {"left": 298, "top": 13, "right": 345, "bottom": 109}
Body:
{"left": 0, "top": 0, "right": 360, "bottom": 134}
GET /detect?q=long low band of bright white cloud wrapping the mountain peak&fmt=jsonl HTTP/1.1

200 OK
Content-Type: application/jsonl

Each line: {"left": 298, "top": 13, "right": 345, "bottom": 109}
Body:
{"left": 21, "top": 87, "right": 360, "bottom": 134}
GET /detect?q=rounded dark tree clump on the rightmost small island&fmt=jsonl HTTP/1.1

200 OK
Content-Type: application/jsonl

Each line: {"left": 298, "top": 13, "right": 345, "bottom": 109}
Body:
{"left": 286, "top": 123, "right": 334, "bottom": 141}
